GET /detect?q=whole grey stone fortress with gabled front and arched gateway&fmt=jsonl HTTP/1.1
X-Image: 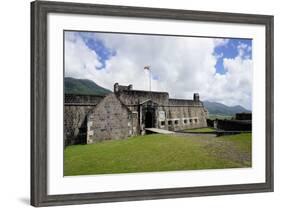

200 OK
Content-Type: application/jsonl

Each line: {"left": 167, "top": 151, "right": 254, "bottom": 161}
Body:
{"left": 64, "top": 83, "right": 207, "bottom": 146}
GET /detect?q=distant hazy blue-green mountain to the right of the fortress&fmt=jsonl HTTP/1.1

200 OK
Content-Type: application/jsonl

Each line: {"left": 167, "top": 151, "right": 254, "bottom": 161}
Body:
{"left": 203, "top": 101, "right": 251, "bottom": 116}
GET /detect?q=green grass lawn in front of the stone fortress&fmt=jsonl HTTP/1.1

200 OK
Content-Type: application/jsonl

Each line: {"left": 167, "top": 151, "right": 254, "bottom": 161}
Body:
{"left": 64, "top": 133, "right": 251, "bottom": 176}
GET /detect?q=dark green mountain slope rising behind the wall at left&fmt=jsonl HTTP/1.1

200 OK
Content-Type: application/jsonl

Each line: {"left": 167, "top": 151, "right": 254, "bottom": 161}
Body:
{"left": 64, "top": 77, "right": 111, "bottom": 95}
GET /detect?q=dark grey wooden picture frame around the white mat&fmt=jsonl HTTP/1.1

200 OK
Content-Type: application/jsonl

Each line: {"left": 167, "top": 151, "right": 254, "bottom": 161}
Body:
{"left": 31, "top": 1, "right": 274, "bottom": 206}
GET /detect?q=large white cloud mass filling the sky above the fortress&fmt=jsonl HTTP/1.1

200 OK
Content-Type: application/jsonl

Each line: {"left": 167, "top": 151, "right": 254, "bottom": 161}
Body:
{"left": 65, "top": 33, "right": 252, "bottom": 109}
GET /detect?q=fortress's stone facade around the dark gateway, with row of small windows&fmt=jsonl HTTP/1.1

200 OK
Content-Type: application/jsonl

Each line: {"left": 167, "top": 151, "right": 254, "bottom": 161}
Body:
{"left": 117, "top": 90, "right": 207, "bottom": 132}
